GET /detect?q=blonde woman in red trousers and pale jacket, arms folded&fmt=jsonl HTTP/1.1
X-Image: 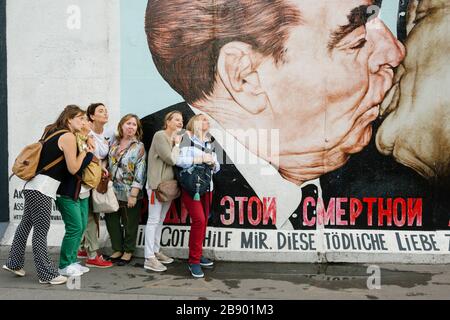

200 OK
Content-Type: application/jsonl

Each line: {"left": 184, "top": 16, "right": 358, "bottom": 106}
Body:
{"left": 177, "top": 114, "right": 220, "bottom": 278}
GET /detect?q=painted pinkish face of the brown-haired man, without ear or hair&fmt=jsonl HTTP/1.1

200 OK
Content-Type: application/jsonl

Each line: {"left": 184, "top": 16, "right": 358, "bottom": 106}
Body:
{"left": 257, "top": 0, "right": 405, "bottom": 183}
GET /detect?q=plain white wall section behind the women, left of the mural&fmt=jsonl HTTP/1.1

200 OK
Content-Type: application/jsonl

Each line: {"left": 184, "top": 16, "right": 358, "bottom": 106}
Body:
{"left": 5, "top": 0, "right": 120, "bottom": 245}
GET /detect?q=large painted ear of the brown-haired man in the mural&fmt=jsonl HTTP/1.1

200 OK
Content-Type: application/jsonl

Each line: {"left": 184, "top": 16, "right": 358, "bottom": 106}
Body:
{"left": 217, "top": 41, "right": 268, "bottom": 114}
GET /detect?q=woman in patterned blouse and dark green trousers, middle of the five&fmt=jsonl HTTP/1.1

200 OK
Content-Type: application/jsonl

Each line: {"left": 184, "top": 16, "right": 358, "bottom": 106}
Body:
{"left": 105, "top": 114, "right": 146, "bottom": 266}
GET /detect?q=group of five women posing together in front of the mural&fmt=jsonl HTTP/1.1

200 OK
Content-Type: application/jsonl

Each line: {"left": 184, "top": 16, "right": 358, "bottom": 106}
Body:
{"left": 3, "top": 103, "right": 220, "bottom": 284}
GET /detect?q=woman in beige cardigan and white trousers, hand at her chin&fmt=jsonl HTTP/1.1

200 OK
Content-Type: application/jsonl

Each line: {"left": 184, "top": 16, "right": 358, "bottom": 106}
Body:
{"left": 144, "top": 111, "right": 183, "bottom": 272}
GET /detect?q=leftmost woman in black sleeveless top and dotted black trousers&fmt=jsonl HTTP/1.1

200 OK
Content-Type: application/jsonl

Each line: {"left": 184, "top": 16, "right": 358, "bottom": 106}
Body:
{"left": 3, "top": 105, "right": 92, "bottom": 285}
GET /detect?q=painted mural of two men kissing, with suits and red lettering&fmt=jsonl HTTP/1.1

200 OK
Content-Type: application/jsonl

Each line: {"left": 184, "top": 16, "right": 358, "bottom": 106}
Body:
{"left": 143, "top": 0, "right": 450, "bottom": 239}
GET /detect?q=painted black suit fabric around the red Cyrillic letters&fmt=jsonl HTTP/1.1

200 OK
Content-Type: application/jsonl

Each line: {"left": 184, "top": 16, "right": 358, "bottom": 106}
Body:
{"left": 141, "top": 102, "right": 450, "bottom": 230}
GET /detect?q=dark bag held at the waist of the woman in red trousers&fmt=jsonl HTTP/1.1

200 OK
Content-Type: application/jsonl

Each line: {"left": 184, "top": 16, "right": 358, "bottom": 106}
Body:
{"left": 174, "top": 137, "right": 214, "bottom": 201}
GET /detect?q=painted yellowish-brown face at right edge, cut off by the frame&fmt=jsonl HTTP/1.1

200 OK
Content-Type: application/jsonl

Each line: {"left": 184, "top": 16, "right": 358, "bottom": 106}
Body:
{"left": 376, "top": 0, "right": 450, "bottom": 180}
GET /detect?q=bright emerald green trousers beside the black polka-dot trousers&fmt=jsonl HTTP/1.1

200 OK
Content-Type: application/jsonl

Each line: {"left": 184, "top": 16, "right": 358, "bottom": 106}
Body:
{"left": 56, "top": 196, "right": 89, "bottom": 269}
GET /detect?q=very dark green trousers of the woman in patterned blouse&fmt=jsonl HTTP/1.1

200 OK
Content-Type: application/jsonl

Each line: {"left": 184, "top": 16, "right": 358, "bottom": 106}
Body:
{"left": 105, "top": 200, "right": 141, "bottom": 254}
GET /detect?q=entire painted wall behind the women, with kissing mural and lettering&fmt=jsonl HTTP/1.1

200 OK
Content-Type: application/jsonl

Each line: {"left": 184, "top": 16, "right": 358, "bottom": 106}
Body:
{"left": 3, "top": 0, "right": 450, "bottom": 263}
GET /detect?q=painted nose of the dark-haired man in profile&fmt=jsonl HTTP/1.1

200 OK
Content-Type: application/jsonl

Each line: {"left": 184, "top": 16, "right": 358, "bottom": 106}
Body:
{"left": 367, "top": 18, "right": 406, "bottom": 73}
